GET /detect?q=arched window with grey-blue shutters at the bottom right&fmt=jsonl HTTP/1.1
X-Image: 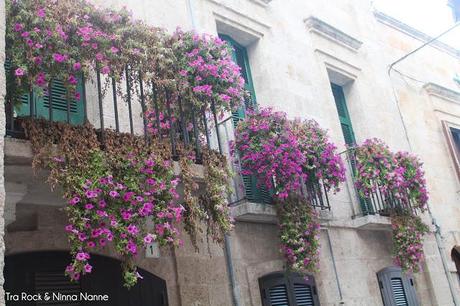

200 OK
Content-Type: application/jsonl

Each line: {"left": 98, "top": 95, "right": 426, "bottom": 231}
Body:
{"left": 377, "top": 267, "right": 418, "bottom": 306}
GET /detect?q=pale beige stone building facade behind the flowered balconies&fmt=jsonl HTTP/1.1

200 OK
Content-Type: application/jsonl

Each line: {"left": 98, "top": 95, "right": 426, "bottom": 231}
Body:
{"left": 0, "top": 0, "right": 460, "bottom": 306}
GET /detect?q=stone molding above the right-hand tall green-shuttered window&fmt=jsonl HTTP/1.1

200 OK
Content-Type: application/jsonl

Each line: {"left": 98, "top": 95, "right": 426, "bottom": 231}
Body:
{"left": 304, "top": 16, "right": 363, "bottom": 51}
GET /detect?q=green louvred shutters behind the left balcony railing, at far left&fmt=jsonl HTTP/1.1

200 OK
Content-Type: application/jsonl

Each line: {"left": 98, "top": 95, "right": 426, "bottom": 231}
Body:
{"left": 5, "top": 61, "right": 85, "bottom": 124}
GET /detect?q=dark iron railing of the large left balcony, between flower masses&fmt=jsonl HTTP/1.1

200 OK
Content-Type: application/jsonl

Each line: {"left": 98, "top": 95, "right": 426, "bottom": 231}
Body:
{"left": 6, "top": 67, "right": 222, "bottom": 161}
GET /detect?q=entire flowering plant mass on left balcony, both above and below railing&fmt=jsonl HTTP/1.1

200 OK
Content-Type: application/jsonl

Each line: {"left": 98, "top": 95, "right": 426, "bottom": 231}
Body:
{"left": 6, "top": 0, "right": 246, "bottom": 287}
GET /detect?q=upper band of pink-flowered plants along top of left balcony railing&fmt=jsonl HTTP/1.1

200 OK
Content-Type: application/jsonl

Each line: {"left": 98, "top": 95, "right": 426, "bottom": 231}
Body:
{"left": 6, "top": 0, "right": 246, "bottom": 116}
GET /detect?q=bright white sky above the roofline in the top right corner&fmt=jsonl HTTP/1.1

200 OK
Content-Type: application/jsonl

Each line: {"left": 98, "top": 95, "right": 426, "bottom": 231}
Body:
{"left": 372, "top": 0, "right": 460, "bottom": 49}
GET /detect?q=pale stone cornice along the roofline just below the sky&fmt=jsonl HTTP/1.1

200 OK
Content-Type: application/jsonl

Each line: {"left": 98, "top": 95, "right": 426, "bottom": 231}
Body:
{"left": 374, "top": 11, "right": 460, "bottom": 58}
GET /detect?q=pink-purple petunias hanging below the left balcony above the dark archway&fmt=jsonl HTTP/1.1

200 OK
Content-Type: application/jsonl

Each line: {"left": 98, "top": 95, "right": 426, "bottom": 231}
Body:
{"left": 65, "top": 155, "right": 183, "bottom": 285}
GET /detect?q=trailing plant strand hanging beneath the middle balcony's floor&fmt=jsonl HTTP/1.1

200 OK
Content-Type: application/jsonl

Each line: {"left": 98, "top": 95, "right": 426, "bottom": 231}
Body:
{"left": 276, "top": 195, "right": 320, "bottom": 274}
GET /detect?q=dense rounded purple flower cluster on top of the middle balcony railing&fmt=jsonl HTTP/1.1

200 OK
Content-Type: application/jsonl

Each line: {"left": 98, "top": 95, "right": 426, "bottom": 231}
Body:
{"left": 231, "top": 108, "right": 345, "bottom": 198}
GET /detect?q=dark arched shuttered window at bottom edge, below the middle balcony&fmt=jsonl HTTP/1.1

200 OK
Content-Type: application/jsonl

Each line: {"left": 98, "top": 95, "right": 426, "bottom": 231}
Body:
{"left": 259, "top": 272, "right": 319, "bottom": 306}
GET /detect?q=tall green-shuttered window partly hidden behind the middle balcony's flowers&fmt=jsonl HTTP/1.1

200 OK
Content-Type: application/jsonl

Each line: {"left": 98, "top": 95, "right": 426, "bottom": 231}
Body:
{"left": 219, "top": 35, "right": 272, "bottom": 203}
